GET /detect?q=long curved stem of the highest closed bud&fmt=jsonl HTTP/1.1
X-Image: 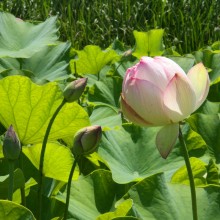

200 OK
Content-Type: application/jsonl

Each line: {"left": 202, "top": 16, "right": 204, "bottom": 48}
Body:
{"left": 38, "top": 99, "right": 66, "bottom": 220}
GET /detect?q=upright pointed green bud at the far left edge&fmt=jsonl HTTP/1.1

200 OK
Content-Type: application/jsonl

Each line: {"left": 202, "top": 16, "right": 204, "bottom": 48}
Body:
{"left": 3, "top": 125, "right": 21, "bottom": 160}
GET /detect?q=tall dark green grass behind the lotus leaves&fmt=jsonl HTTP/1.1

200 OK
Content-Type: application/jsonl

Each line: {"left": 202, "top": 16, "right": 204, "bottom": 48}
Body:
{"left": 0, "top": 0, "right": 220, "bottom": 53}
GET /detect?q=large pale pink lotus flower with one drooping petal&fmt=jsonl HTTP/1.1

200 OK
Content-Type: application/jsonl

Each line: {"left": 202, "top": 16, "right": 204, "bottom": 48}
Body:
{"left": 121, "top": 57, "right": 210, "bottom": 158}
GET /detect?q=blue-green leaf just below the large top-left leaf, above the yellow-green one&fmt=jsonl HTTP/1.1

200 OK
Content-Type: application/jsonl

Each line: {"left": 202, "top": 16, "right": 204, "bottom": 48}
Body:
{"left": 0, "top": 43, "right": 70, "bottom": 83}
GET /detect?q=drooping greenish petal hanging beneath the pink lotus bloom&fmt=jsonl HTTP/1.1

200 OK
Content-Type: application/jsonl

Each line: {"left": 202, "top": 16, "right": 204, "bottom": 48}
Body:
{"left": 156, "top": 124, "right": 179, "bottom": 159}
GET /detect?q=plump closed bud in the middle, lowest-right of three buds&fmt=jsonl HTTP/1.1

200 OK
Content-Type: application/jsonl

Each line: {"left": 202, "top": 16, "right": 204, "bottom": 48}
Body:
{"left": 72, "top": 125, "right": 102, "bottom": 156}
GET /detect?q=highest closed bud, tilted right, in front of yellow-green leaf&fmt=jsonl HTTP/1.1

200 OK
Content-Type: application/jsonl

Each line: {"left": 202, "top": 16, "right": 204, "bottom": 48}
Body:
{"left": 63, "top": 78, "right": 87, "bottom": 102}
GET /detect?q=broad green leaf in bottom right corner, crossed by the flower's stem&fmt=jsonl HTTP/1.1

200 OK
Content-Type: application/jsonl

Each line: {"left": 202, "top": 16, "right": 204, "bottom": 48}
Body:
{"left": 124, "top": 174, "right": 220, "bottom": 220}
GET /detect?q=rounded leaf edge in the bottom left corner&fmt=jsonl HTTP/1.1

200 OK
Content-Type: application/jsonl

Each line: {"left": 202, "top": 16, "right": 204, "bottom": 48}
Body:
{"left": 0, "top": 200, "right": 35, "bottom": 220}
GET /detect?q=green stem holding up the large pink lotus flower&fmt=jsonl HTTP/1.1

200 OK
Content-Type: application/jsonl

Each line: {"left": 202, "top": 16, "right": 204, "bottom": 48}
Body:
{"left": 179, "top": 126, "right": 198, "bottom": 220}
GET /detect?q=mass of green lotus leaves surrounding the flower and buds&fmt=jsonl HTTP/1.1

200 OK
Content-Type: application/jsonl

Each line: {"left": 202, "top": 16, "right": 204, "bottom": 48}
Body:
{"left": 0, "top": 11, "right": 220, "bottom": 220}
